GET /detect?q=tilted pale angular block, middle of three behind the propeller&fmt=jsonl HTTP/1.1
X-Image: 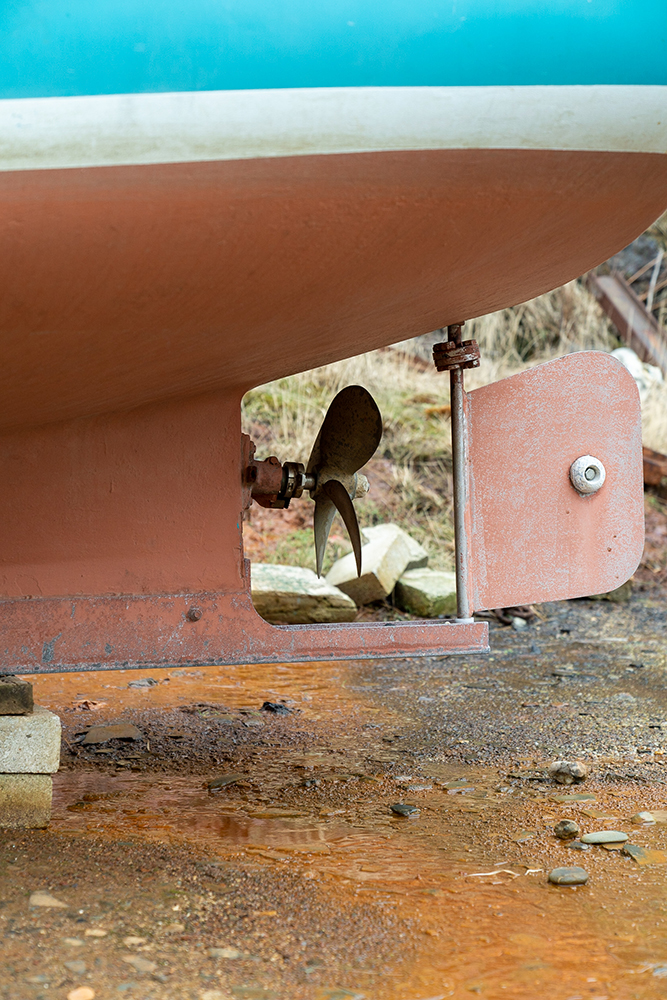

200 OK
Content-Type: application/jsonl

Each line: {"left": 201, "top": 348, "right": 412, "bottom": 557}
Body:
{"left": 326, "top": 532, "right": 410, "bottom": 605}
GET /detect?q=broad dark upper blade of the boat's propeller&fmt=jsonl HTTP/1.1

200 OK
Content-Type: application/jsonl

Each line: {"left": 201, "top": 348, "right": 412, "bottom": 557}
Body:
{"left": 307, "top": 385, "right": 382, "bottom": 477}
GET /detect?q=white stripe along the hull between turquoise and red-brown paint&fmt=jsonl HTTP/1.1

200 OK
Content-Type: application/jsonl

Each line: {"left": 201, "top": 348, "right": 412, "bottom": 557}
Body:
{"left": 0, "top": 86, "right": 667, "bottom": 171}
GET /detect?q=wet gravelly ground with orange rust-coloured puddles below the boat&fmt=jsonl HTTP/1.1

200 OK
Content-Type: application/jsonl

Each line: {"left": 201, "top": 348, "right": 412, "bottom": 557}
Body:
{"left": 0, "top": 590, "right": 667, "bottom": 1000}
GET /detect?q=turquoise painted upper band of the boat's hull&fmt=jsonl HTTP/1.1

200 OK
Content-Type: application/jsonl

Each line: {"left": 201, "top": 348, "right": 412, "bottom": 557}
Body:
{"left": 0, "top": 0, "right": 667, "bottom": 98}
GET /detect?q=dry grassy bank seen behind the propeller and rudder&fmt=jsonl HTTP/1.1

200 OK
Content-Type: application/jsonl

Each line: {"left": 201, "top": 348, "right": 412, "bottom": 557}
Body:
{"left": 243, "top": 281, "right": 667, "bottom": 568}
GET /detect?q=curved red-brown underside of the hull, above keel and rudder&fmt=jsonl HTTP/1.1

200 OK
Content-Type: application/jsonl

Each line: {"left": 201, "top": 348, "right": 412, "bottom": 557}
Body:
{"left": 0, "top": 149, "right": 667, "bottom": 428}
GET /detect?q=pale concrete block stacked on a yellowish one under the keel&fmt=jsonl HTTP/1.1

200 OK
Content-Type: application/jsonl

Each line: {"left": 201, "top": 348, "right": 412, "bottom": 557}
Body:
{"left": 0, "top": 705, "right": 60, "bottom": 774}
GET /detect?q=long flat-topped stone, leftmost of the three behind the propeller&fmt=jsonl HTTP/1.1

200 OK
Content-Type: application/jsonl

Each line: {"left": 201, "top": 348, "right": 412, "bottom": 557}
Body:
{"left": 250, "top": 563, "right": 357, "bottom": 625}
